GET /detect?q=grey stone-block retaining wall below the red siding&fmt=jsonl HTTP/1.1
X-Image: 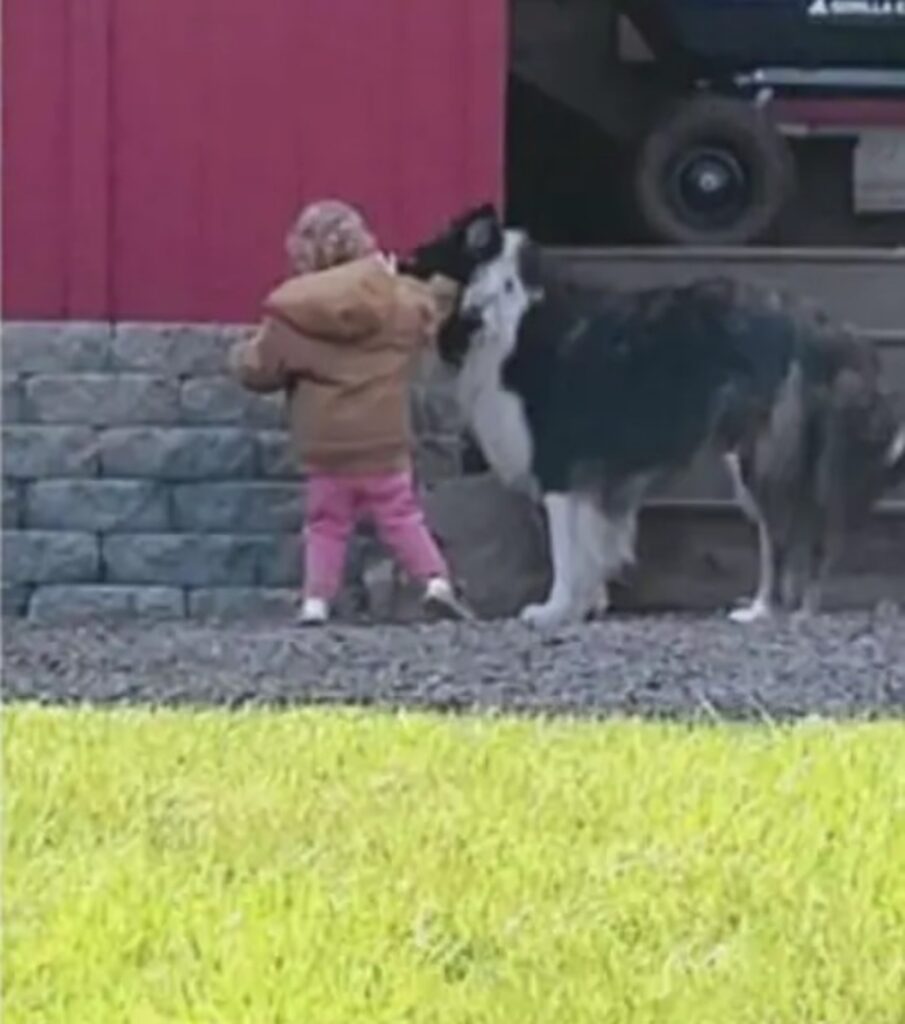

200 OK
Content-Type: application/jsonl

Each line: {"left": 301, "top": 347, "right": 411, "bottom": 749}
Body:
{"left": 2, "top": 323, "right": 461, "bottom": 621}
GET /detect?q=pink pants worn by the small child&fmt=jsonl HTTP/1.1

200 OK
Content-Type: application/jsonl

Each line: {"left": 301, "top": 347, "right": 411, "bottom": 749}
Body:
{"left": 305, "top": 471, "right": 448, "bottom": 601}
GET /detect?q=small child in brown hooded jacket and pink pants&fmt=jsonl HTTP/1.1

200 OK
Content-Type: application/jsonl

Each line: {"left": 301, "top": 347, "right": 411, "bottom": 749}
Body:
{"left": 230, "top": 200, "right": 467, "bottom": 625}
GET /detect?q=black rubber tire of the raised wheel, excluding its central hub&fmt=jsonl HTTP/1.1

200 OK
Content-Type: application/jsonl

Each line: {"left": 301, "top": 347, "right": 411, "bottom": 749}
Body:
{"left": 634, "top": 96, "right": 795, "bottom": 246}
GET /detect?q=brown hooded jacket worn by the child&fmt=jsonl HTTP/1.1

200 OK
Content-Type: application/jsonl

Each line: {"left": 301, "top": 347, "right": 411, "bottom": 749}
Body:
{"left": 230, "top": 255, "right": 456, "bottom": 473}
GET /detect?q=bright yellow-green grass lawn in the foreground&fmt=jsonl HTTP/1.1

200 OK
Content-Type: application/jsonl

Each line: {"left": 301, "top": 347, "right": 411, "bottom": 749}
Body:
{"left": 3, "top": 708, "right": 905, "bottom": 1024}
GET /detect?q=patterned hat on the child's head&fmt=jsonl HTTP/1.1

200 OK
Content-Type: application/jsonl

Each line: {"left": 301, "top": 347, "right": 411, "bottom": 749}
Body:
{"left": 286, "top": 199, "right": 377, "bottom": 273}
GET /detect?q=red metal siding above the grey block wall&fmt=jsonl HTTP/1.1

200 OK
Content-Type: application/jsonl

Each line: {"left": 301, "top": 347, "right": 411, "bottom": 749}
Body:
{"left": 3, "top": 0, "right": 506, "bottom": 319}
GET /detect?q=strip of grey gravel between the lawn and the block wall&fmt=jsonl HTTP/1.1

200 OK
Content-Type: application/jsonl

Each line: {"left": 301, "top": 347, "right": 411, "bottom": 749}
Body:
{"left": 3, "top": 611, "right": 905, "bottom": 720}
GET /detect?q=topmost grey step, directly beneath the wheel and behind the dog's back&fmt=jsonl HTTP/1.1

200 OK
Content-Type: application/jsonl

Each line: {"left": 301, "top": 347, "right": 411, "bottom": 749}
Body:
{"left": 551, "top": 246, "right": 905, "bottom": 329}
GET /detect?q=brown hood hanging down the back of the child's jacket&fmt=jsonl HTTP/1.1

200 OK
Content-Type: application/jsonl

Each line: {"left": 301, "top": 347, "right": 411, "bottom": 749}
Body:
{"left": 264, "top": 256, "right": 395, "bottom": 342}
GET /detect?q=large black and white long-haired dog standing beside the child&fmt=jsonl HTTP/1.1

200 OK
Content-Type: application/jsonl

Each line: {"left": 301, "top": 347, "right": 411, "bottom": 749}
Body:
{"left": 405, "top": 206, "right": 905, "bottom": 627}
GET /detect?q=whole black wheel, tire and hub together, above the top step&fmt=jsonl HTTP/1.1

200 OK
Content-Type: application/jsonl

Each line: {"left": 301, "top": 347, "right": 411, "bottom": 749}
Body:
{"left": 634, "top": 96, "right": 795, "bottom": 246}
